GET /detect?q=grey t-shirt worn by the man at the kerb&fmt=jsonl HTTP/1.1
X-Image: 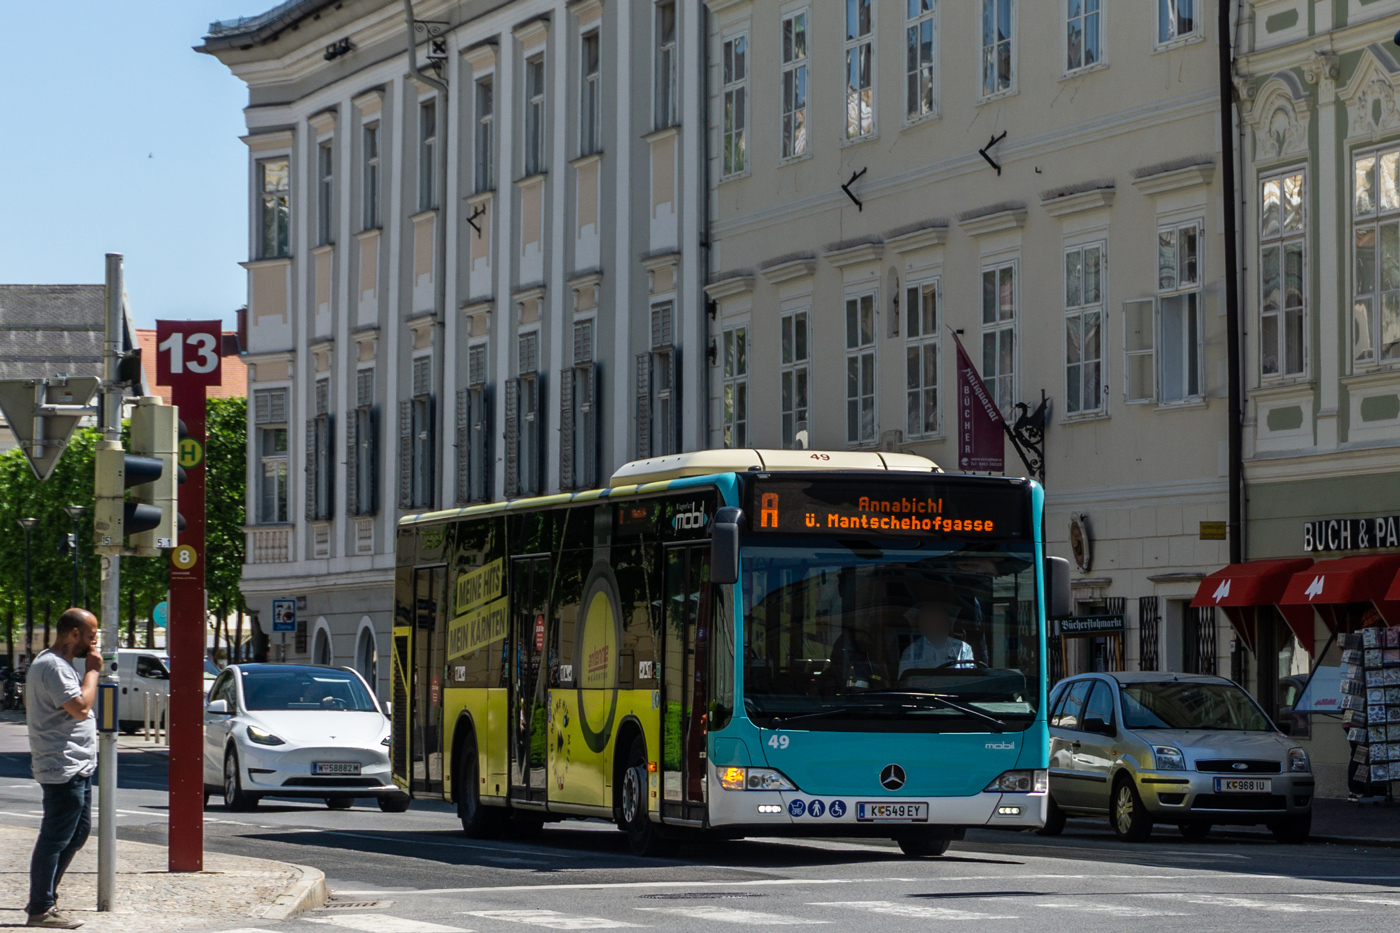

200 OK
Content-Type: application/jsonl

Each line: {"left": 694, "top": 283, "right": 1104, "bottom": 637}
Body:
{"left": 24, "top": 651, "right": 97, "bottom": 785}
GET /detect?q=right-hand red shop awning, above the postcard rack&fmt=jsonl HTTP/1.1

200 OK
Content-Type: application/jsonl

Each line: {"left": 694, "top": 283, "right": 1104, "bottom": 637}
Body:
{"left": 1278, "top": 553, "right": 1400, "bottom": 646}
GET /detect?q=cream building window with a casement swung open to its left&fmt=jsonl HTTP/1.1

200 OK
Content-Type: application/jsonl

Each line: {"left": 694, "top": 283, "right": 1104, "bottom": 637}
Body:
{"left": 1154, "top": 217, "right": 1207, "bottom": 406}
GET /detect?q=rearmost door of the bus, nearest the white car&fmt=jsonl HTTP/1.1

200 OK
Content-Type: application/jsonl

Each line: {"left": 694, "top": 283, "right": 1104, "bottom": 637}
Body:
{"left": 410, "top": 567, "right": 447, "bottom": 796}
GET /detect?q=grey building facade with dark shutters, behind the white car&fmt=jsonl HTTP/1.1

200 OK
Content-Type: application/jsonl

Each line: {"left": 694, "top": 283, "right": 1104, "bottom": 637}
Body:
{"left": 200, "top": 0, "right": 707, "bottom": 693}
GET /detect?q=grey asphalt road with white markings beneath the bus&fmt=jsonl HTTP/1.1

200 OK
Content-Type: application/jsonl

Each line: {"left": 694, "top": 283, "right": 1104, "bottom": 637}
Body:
{"left": 0, "top": 724, "right": 1400, "bottom": 933}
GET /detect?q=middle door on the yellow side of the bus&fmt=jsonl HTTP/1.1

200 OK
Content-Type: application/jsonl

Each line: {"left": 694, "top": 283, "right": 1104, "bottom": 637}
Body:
{"left": 511, "top": 555, "right": 550, "bottom": 803}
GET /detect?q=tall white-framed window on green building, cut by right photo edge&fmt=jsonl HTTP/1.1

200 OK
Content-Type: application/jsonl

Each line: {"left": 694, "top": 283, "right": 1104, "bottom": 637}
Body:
{"left": 1348, "top": 143, "right": 1400, "bottom": 371}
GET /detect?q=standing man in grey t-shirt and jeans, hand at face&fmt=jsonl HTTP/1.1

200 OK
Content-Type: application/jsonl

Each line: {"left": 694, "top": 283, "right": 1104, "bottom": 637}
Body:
{"left": 25, "top": 608, "right": 102, "bottom": 930}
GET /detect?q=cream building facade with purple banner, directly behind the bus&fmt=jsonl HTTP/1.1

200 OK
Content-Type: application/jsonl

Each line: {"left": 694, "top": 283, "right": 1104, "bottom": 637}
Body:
{"left": 707, "top": 0, "right": 1232, "bottom": 674}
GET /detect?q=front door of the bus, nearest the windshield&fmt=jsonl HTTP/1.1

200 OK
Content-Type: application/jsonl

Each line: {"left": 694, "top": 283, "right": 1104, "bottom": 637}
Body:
{"left": 661, "top": 542, "right": 713, "bottom": 822}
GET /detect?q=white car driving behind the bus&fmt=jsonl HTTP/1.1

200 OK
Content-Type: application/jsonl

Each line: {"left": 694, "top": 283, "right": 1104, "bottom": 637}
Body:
{"left": 204, "top": 664, "right": 409, "bottom": 813}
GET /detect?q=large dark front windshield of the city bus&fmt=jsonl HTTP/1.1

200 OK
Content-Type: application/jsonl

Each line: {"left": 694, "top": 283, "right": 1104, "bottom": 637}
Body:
{"left": 741, "top": 537, "right": 1040, "bottom": 731}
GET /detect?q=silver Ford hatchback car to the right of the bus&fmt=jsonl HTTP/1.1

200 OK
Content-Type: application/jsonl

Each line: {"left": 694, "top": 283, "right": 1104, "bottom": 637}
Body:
{"left": 1040, "top": 671, "right": 1313, "bottom": 842}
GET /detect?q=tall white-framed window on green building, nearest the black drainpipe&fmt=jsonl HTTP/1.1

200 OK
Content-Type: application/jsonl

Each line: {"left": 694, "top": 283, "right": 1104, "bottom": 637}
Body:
{"left": 1259, "top": 165, "right": 1304, "bottom": 382}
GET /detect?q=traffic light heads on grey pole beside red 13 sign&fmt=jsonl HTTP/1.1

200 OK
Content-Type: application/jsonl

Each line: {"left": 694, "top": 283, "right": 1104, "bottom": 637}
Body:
{"left": 92, "top": 398, "right": 178, "bottom": 555}
